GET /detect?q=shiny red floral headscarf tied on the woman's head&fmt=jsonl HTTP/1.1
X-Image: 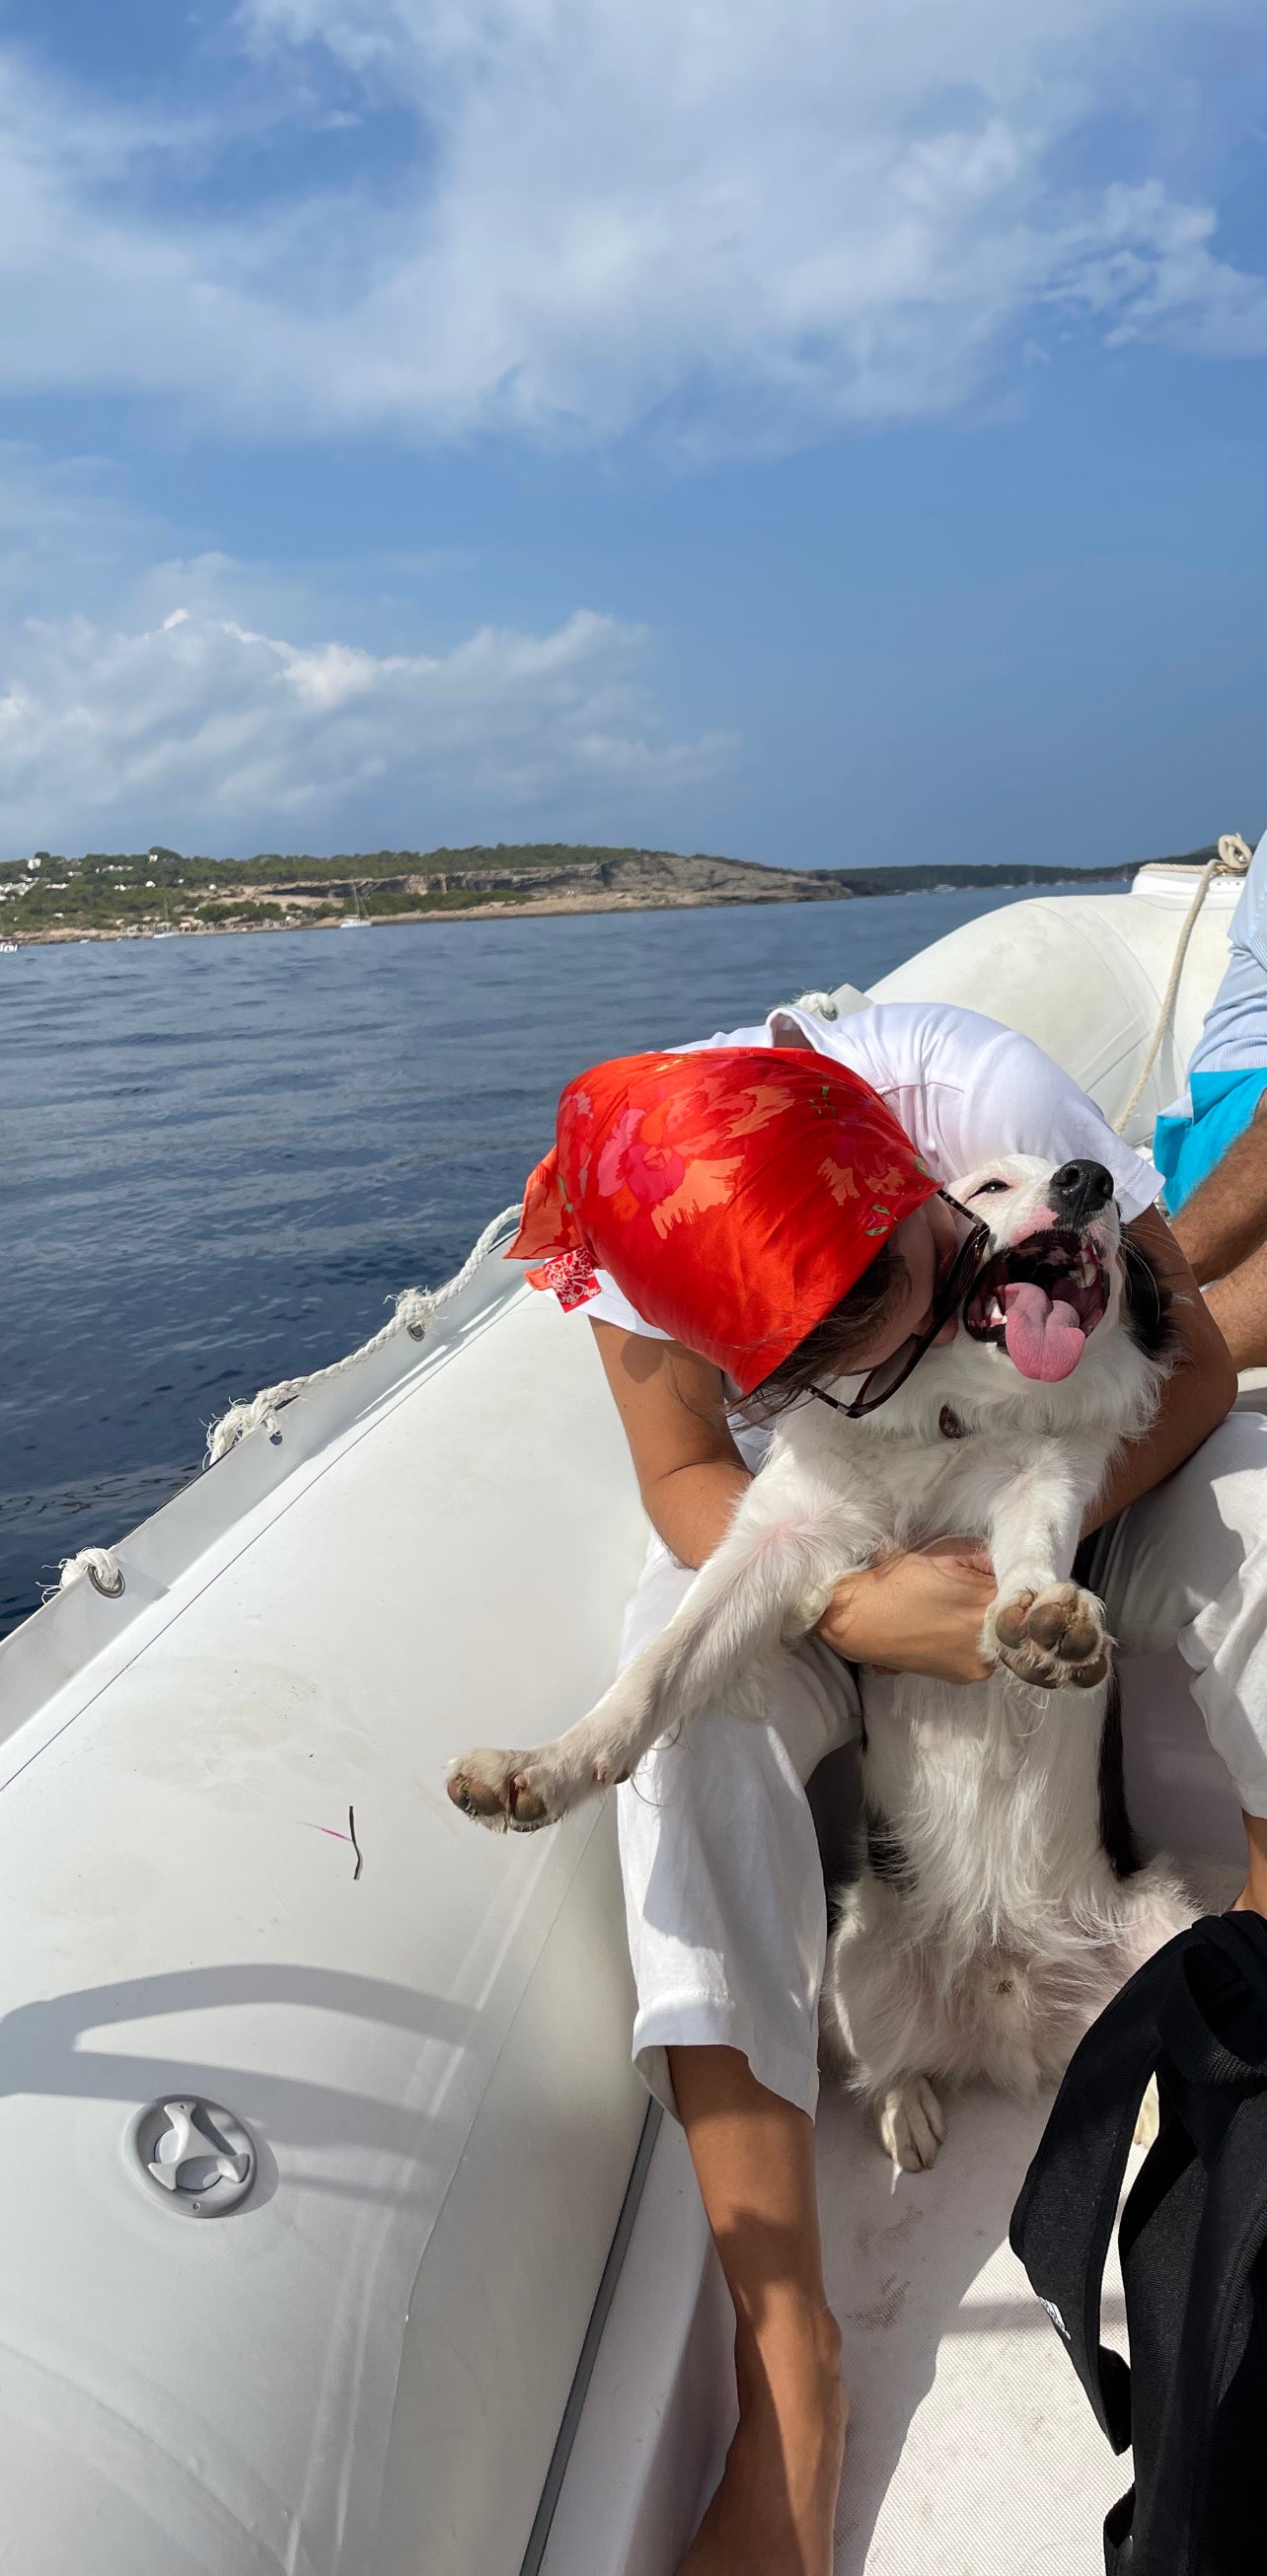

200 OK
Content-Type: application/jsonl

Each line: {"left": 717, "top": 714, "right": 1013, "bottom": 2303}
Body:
{"left": 507, "top": 1046, "right": 937, "bottom": 1396}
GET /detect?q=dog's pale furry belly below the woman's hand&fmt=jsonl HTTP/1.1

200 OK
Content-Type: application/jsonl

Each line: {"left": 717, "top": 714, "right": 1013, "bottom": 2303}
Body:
{"left": 824, "top": 1674, "right": 1143, "bottom": 2095}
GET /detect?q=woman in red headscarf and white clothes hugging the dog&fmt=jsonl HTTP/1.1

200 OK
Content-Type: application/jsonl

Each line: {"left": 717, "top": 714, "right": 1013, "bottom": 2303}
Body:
{"left": 504, "top": 1004, "right": 1246, "bottom": 2576}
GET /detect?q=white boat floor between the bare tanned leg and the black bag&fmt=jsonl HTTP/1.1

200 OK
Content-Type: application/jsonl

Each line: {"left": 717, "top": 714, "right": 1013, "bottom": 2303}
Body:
{"left": 819, "top": 2092, "right": 1139, "bottom": 2576}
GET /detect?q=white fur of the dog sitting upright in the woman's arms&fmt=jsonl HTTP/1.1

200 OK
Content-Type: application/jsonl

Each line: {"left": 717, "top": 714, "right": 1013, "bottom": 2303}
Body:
{"left": 448, "top": 1156, "right": 1192, "bottom": 2167}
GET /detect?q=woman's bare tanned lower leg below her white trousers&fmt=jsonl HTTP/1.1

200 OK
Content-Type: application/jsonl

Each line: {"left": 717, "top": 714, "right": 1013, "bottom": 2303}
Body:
{"left": 670, "top": 2048, "right": 848, "bottom": 2576}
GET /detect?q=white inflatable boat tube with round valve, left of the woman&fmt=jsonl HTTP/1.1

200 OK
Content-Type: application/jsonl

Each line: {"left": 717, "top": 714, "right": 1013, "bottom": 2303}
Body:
{"left": 0, "top": 1273, "right": 643, "bottom": 2576}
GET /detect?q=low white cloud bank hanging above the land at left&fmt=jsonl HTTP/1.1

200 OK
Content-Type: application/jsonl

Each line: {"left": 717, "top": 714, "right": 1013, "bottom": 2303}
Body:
{"left": 0, "top": 446, "right": 734, "bottom": 857}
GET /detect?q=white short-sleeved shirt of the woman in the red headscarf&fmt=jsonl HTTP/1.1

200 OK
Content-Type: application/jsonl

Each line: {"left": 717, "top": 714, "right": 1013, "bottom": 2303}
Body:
{"left": 577, "top": 1002, "right": 1161, "bottom": 1342}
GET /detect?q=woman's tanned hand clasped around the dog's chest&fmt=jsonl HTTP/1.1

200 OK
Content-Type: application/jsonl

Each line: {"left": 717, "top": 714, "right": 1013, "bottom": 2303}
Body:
{"left": 816, "top": 1538, "right": 997, "bottom": 1682}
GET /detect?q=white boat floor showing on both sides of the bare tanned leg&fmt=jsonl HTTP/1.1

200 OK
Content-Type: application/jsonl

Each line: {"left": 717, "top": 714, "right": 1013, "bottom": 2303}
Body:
{"left": 543, "top": 1860, "right": 1238, "bottom": 2576}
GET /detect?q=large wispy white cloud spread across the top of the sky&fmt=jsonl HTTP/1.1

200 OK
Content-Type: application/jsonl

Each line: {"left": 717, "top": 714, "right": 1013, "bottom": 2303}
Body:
{"left": 0, "top": 0, "right": 1267, "bottom": 448}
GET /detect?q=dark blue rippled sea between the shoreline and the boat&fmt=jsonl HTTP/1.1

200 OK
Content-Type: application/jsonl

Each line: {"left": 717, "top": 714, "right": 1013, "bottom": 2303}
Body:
{"left": 0, "top": 891, "right": 1086, "bottom": 1631}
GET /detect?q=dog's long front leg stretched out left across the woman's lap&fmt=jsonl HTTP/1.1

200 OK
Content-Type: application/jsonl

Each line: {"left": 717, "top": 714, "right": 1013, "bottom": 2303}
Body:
{"left": 448, "top": 1471, "right": 875, "bottom": 1831}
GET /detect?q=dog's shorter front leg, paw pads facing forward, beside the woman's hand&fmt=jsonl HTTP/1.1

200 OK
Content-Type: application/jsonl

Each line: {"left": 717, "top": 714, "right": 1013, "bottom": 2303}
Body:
{"left": 984, "top": 1453, "right": 1110, "bottom": 1690}
